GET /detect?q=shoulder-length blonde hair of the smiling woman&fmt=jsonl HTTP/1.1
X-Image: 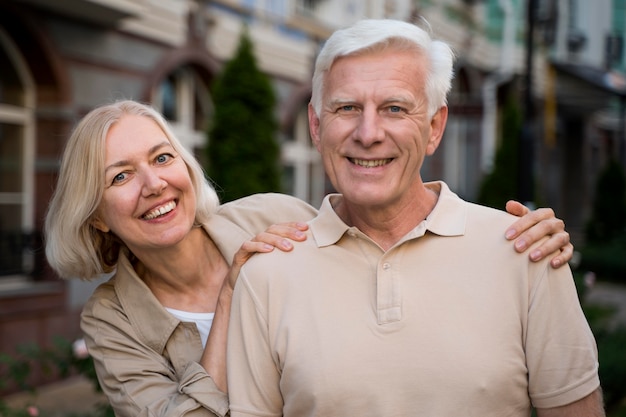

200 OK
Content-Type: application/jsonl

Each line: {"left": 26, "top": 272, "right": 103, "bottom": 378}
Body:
{"left": 44, "top": 100, "right": 219, "bottom": 280}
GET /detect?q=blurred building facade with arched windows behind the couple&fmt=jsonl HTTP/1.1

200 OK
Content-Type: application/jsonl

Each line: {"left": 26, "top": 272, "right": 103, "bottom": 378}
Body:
{"left": 0, "top": 0, "right": 626, "bottom": 390}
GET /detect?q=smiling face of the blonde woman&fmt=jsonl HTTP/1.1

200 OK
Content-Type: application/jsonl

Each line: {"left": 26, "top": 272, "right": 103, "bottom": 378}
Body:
{"left": 94, "top": 115, "right": 196, "bottom": 257}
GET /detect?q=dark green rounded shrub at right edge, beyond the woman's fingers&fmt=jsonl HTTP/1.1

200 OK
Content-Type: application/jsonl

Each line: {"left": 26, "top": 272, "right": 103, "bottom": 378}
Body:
{"left": 586, "top": 160, "right": 626, "bottom": 243}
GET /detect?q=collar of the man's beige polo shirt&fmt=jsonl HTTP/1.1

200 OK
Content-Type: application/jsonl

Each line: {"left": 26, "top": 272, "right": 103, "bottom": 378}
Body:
{"left": 310, "top": 181, "right": 467, "bottom": 247}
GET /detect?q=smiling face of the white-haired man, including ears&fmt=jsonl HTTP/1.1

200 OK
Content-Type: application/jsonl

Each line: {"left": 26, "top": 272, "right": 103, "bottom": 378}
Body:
{"left": 309, "top": 50, "right": 447, "bottom": 209}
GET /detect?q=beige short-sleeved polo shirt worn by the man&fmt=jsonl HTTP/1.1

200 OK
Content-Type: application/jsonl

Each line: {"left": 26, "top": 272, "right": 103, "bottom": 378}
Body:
{"left": 227, "top": 183, "right": 599, "bottom": 417}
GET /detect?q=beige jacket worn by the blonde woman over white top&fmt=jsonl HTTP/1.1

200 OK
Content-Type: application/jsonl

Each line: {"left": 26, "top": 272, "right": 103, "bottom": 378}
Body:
{"left": 81, "top": 194, "right": 316, "bottom": 417}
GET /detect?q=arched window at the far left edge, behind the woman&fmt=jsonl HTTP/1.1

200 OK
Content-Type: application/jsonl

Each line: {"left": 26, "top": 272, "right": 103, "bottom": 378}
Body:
{"left": 0, "top": 28, "right": 35, "bottom": 284}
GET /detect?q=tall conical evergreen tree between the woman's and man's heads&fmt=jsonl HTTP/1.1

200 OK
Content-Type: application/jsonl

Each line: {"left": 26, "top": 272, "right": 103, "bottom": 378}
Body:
{"left": 206, "top": 26, "right": 280, "bottom": 201}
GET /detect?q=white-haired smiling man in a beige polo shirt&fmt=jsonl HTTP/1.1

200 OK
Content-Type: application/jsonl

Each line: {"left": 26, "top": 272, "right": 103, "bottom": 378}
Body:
{"left": 227, "top": 20, "right": 604, "bottom": 417}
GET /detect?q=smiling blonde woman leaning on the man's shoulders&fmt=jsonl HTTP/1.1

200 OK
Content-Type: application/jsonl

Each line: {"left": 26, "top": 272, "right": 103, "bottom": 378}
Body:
{"left": 45, "top": 101, "right": 572, "bottom": 416}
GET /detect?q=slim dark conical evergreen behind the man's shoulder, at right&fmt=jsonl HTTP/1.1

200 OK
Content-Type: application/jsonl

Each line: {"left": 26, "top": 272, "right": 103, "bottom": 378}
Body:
{"left": 478, "top": 96, "right": 522, "bottom": 209}
